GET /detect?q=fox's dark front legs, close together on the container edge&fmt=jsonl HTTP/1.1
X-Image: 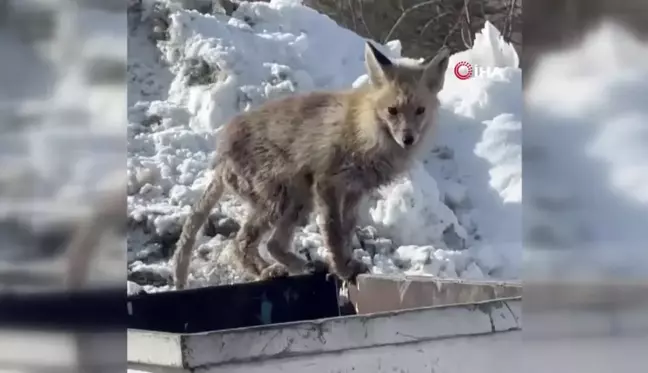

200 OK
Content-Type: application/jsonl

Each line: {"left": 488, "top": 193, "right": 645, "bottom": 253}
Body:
{"left": 315, "top": 183, "right": 368, "bottom": 281}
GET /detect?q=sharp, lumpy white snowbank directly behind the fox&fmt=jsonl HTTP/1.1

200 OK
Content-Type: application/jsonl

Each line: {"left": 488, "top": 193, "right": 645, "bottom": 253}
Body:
{"left": 128, "top": 0, "right": 522, "bottom": 291}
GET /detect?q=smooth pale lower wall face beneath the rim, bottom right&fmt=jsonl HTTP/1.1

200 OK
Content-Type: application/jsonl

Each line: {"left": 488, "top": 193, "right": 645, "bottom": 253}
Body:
{"left": 132, "top": 331, "right": 523, "bottom": 373}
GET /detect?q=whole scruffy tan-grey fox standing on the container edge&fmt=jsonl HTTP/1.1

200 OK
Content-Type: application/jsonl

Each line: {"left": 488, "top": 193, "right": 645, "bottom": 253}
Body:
{"left": 173, "top": 40, "right": 449, "bottom": 290}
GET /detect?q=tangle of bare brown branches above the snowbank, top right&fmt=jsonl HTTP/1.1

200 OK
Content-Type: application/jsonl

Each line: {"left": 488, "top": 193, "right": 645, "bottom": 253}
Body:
{"left": 304, "top": 0, "right": 522, "bottom": 56}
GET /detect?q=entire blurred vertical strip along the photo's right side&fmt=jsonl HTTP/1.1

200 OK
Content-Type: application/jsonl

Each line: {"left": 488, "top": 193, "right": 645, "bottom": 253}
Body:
{"left": 520, "top": 0, "right": 648, "bottom": 373}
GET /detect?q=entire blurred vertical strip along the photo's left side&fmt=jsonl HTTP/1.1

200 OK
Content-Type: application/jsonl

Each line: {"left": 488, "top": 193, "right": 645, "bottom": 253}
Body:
{"left": 0, "top": 0, "right": 126, "bottom": 372}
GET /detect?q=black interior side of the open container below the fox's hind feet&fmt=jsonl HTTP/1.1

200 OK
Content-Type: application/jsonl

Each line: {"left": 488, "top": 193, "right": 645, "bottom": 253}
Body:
{"left": 128, "top": 274, "right": 341, "bottom": 333}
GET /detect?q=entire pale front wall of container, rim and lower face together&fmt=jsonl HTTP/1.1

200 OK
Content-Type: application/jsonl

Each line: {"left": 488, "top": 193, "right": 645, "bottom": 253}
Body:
{"left": 128, "top": 298, "right": 521, "bottom": 373}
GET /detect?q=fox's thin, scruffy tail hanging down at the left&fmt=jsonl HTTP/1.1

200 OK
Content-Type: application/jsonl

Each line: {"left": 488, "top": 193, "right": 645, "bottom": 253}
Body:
{"left": 173, "top": 167, "right": 224, "bottom": 290}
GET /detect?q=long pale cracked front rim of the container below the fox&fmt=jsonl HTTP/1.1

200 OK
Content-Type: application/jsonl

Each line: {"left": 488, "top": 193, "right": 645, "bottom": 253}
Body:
{"left": 128, "top": 297, "right": 521, "bottom": 371}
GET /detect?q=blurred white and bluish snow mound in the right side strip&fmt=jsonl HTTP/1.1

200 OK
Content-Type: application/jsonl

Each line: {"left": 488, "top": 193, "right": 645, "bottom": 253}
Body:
{"left": 524, "top": 23, "right": 648, "bottom": 276}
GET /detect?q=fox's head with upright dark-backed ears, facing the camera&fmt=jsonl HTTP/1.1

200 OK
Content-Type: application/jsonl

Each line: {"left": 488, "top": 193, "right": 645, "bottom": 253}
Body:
{"left": 365, "top": 42, "right": 449, "bottom": 149}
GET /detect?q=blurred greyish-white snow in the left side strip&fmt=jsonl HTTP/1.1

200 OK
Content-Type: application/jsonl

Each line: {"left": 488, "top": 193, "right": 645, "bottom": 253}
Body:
{"left": 0, "top": 0, "right": 126, "bottom": 290}
